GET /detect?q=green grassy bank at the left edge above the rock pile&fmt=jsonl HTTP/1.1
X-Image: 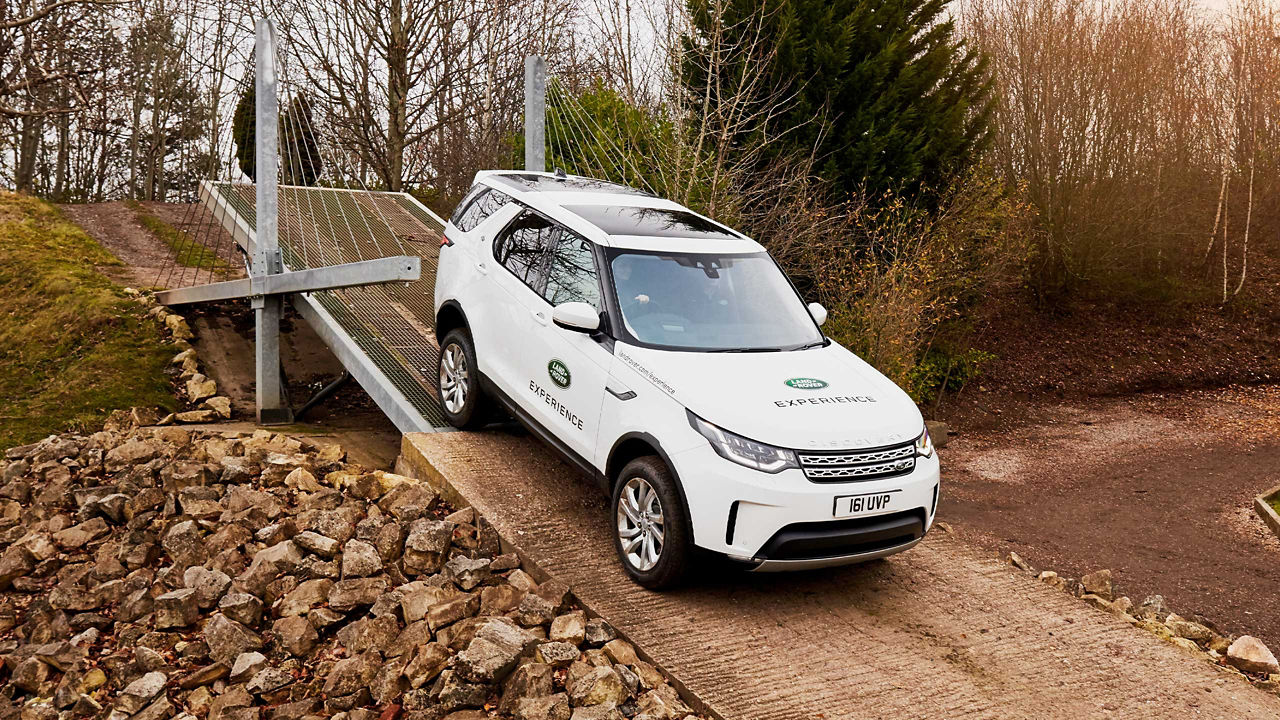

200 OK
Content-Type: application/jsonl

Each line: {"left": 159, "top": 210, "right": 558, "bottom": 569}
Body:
{"left": 0, "top": 192, "right": 174, "bottom": 447}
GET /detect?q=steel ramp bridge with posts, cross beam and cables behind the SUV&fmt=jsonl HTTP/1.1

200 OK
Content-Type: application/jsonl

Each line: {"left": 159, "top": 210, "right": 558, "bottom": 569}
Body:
{"left": 156, "top": 20, "right": 483, "bottom": 433}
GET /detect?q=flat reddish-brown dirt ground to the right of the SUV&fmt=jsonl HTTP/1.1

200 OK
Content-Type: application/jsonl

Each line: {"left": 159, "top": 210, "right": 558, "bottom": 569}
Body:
{"left": 940, "top": 387, "right": 1280, "bottom": 648}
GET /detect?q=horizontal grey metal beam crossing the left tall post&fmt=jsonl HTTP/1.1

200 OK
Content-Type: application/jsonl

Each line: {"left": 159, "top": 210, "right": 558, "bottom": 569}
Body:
{"left": 156, "top": 255, "right": 422, "bottom": 305}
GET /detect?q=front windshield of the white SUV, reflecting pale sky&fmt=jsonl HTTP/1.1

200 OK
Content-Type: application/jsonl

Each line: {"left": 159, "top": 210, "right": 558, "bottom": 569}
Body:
{"left": 609, "top": 250, "right": 823, "bottom": 352}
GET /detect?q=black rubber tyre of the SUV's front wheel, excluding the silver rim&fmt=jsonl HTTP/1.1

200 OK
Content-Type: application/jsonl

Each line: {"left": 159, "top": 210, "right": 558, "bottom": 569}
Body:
{"left": 609, "top": 455, "right": 694, "bottom": 589}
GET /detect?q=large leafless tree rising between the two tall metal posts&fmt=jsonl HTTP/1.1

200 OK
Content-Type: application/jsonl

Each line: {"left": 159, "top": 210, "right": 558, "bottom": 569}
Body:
{"left": 280, "top": 0, "right": 572, "bottom": 196}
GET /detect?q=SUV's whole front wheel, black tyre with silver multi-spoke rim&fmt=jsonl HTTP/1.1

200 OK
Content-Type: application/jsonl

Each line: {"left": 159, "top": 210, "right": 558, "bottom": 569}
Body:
{"left": 612, "top": 455, "right": 692, "bottom": 589}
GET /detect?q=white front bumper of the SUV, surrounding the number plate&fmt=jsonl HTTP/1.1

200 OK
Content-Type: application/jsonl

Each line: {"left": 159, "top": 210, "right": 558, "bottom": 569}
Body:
{"left": 672, "top": 445, "right": 938, "bottom": 563}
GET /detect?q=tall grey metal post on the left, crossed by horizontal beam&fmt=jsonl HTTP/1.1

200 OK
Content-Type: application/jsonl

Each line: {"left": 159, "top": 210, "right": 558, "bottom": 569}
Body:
{"left": 250, "top": 19, "right": 293, "bottom": 425}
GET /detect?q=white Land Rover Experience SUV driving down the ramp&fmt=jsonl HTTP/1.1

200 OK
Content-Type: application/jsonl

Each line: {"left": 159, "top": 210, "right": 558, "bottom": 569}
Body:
{"left": 435, "top": 172, "right": 938, "bottom": 588}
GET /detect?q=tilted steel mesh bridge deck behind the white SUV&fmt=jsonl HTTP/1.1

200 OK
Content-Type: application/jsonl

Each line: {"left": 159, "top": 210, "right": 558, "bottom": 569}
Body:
{"left": 200, "top": 182, "right": 448, "bottom": 432}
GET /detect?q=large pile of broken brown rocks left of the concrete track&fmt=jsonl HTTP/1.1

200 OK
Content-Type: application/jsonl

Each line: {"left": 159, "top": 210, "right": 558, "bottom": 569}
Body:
{"left": 0, "top": 427, "right": 691, "bottom": 720}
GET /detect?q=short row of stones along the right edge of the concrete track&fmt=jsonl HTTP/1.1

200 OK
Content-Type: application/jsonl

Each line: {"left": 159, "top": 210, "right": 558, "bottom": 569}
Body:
{"left": 1009, "top": 552, "right": 1280, "bottom": 694}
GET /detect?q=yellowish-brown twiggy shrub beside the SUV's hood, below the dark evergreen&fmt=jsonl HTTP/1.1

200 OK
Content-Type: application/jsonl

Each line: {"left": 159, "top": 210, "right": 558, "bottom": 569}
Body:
{"left": 767, "top": 176, "right": 1037, "bottom": 400}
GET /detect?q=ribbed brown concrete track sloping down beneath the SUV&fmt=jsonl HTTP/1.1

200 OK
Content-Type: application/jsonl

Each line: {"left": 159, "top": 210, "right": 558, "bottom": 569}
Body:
{"left": 401, "top": 432, "right": 1280, "bottom": 720}
